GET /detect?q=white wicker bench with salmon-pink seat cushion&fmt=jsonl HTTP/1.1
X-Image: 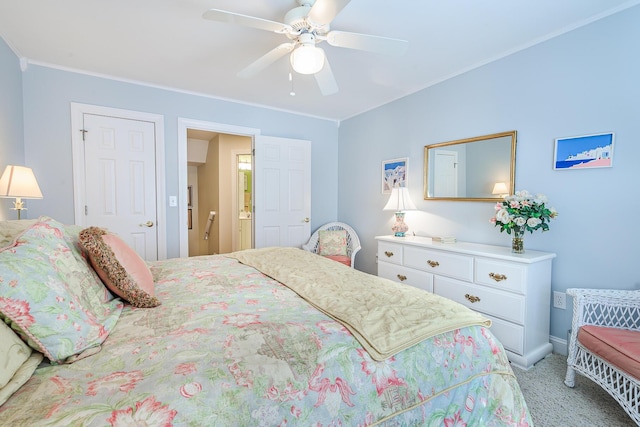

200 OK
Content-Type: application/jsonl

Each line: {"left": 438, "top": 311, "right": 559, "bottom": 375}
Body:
{"left": 564, "top": 288, "right": 640, "bottom": 425}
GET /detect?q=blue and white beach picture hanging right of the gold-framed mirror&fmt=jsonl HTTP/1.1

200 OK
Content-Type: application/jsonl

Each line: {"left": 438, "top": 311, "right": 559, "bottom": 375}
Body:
{"left": 553, "top": 132, "right": 614, "bottom": 170}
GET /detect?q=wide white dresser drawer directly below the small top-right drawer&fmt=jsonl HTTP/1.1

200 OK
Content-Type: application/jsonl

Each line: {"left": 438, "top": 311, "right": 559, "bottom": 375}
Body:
{"left": 433, "top": 276, "right": 525, "bottom": 325}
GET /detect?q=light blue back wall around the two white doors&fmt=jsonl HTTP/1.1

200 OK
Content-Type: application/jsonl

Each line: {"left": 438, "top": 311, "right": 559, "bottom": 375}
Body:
{"left": 23, "top": 65, "right": 338, "bottom": 257}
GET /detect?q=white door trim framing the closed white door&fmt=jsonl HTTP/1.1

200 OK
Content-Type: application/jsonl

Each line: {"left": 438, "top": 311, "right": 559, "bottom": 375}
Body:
{"left": 71, "top": 102, "right": 167, "bottom": 260}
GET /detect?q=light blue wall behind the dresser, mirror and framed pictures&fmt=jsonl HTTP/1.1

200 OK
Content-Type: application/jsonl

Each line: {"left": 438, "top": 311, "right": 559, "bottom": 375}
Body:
{"left": 338, "top": 6, "right": 640, "bottom": 339}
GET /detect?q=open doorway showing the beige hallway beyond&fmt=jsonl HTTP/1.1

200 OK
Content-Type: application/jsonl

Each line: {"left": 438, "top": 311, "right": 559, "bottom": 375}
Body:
{"left": 186, "top": 128, "right": 253, "bottom": 256}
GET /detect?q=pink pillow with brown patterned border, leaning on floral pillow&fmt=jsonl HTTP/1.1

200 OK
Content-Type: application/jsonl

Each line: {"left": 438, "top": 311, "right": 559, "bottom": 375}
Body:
{"left": 80, "top": 227, "right": 160, "bottom": 307}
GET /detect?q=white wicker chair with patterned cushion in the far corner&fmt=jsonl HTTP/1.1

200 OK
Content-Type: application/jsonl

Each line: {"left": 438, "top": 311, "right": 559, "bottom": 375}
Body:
{"left": 302, "top": 222, "right": 361, "bottom": 268}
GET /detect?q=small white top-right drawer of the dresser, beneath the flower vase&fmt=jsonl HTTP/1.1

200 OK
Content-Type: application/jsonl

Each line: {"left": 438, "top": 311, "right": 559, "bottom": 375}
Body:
{"left": 475, "top": 258, "right": 527, "bottom": 294}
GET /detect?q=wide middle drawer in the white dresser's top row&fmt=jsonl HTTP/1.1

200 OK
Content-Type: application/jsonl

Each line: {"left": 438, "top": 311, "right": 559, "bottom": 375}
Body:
{"left": 404, "top": 246, "right": 473, "bottom": 282}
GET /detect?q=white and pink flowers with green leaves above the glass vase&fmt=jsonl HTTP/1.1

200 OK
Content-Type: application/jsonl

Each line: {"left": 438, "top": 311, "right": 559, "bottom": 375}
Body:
{"left": 491, "top": 190, "right": 558, "bottom": 234}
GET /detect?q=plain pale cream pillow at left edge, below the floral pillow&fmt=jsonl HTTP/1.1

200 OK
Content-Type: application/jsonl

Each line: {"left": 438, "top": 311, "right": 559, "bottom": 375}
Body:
{"left": 0, "top": 320, "right": 42, "bottom": 405}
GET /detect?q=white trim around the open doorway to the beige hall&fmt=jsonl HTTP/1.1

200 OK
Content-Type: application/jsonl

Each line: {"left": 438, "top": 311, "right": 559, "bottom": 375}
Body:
{"left": 178, "top": 117, "right": 261, "bottom": 258}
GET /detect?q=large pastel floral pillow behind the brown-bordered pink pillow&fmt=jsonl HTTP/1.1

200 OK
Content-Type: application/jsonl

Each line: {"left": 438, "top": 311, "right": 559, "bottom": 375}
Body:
{"left": 0, "top": 218, "right": 122, "bottom": 364}
